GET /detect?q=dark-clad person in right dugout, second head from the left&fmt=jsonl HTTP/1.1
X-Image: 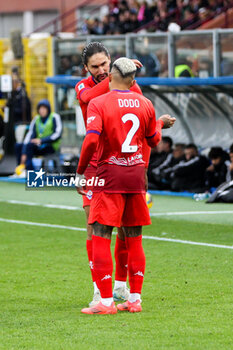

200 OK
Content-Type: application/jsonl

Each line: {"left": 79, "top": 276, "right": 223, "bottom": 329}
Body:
{"left": 152, "top": 143, "right": 185, "bottom": 190}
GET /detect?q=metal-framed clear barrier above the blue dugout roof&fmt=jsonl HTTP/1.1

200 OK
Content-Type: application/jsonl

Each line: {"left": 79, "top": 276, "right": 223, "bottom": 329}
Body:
{"left": 55, "top": 29, "right": 233, "bottom": 77}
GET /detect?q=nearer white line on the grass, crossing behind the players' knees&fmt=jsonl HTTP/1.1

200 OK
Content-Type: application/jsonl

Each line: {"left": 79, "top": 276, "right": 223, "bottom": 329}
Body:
{"left": 0, "top": 218, "right": 233, "bottom": 249}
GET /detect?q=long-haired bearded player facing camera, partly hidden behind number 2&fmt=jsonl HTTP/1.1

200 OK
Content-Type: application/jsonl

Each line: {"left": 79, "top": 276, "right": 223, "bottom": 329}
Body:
{"left": 75, "top": 42, "right": 144, "bottom": 305}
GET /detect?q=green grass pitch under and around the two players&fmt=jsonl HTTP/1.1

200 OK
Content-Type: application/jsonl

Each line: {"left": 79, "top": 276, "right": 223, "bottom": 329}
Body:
{"left": 0, "top": 183, "right": 233, "bottom": 350}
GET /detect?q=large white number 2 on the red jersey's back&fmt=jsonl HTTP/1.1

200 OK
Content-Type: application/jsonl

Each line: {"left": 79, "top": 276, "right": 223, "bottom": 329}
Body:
{"left": 121, "top": 113, "right": 140, "bottom": 153}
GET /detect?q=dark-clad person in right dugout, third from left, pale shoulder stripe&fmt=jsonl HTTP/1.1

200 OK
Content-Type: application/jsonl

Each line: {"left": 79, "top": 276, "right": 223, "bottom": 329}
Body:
{"left": 171, "top": 144, "right": 209, "bottom": 192}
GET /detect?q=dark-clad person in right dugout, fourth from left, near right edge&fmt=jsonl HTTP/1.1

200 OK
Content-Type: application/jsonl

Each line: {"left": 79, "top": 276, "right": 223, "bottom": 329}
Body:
{"left": 206, "top": 147, "right": 230, "bottom": 189}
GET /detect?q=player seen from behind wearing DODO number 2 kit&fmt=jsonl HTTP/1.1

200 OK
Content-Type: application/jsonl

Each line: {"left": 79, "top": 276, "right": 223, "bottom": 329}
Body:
{"left": 77, "top": 58, "right": 175, "bottom": 314}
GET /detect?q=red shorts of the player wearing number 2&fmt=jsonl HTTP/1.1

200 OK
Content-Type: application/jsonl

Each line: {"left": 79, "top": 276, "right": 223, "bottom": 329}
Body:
{"left": 88, "top": 192, "right": 151, "bottom": 227}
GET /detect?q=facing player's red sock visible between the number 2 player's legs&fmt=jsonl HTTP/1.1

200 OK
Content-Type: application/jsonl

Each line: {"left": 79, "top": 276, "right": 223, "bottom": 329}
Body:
{"left": 114, "top": 235, "right": 128, "bottom": 282}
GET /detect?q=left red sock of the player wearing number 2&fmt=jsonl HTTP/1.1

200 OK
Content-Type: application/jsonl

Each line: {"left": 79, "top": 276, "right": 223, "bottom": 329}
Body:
{"left": 92, "top": 235, "right": 113, "bottom": 298}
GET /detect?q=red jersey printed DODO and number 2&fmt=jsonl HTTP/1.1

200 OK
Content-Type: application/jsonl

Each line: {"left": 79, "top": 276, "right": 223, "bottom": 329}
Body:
{"left": 83, "top": 90, "right": 156, "bottom": 193}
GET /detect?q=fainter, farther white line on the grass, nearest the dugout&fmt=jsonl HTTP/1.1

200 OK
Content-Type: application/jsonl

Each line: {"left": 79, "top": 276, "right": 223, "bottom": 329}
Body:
{"left": 2, "top": 199, "right": 233, "bottom": 216}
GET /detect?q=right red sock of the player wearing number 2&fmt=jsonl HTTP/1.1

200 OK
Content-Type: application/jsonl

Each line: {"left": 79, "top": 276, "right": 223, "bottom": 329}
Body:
{"left": 126, "top": 235, "right": 146, "bottom": 294}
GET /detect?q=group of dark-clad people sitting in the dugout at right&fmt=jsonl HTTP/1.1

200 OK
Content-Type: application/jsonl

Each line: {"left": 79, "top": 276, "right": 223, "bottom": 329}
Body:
{"left": 148, "top": 136, "right": 233, "bottom": 193}
